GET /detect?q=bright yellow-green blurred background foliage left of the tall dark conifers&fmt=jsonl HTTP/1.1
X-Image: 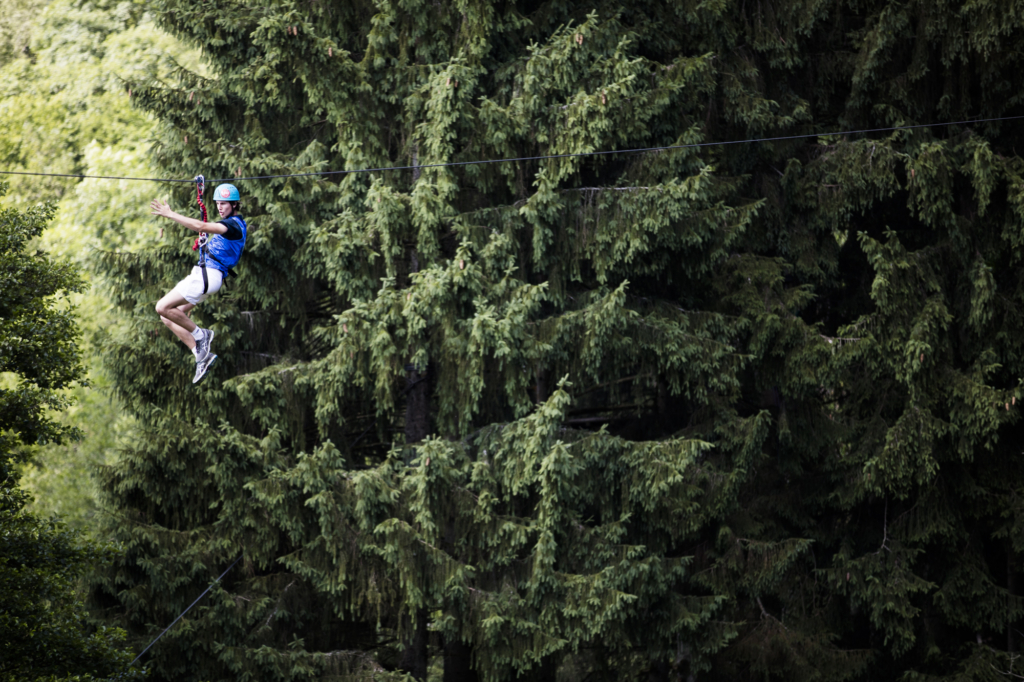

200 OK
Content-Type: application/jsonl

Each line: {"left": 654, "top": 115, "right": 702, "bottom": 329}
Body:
{"left": 0, "top": 0, "right": 196, "bottom": 535}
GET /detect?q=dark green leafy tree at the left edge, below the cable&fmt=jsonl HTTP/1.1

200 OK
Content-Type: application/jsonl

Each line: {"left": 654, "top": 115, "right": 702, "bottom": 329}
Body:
{"left": 0, "top": 184, "right": 136, "bottom": 682}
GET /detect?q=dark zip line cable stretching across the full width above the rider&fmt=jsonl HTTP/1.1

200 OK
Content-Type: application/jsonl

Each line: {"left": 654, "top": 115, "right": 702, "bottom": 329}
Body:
{"left": 0, "top": 116, "right": 1024, "bottom": 183}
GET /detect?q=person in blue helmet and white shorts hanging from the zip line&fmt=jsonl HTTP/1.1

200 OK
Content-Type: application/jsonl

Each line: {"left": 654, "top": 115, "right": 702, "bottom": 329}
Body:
{"left": 150, "top": 176, "right": 247, "bottom": 384}
